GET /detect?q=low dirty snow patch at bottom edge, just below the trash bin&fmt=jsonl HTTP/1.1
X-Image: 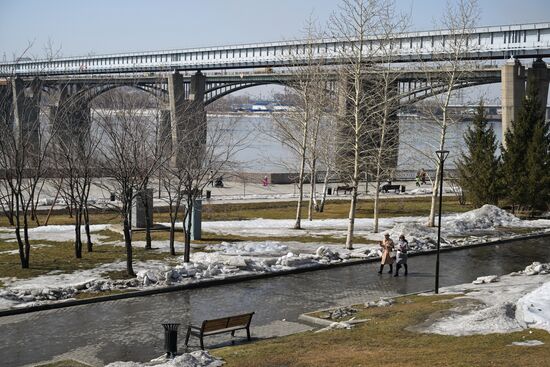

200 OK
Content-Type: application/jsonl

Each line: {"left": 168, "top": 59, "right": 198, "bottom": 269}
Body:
{"left": 105, "top": 350, "right": 225, "bottom": 367}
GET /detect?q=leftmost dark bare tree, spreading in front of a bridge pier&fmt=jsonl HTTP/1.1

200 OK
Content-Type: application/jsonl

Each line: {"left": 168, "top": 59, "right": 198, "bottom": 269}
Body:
{"left": 0, "top": 78, "right": 54, "bottom": 268}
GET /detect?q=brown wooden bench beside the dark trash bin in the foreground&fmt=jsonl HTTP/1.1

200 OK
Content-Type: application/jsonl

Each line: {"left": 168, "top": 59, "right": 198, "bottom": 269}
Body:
{"left": 185, "top": 312, "right": 254, "bottom": 350}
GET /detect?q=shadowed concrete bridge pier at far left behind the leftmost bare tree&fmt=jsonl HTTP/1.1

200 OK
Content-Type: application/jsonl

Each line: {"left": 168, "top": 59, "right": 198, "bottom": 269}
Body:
{"left": 11, "top": 78, "right": 42, "bottom": 159}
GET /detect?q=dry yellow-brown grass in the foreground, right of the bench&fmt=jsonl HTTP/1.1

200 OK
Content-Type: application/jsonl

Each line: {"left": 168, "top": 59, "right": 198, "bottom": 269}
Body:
{"left": 213, "top": 296, "right": 550, "bottom": 367}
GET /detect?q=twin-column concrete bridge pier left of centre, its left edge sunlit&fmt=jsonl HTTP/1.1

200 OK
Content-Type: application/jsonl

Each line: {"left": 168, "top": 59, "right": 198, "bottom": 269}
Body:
{"left": 168, "top": 71, "right": 207, "bottom": 166}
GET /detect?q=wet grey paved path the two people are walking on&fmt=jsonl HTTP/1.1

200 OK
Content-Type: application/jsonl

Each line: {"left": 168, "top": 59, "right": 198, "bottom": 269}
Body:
{"left": 0, "top": 237, "right": 550, "bottom": 366}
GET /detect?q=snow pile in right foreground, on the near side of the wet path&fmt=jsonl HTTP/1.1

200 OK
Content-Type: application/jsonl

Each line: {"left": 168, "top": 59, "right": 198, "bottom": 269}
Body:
{"left": 417, "top": 262, "right": 550, "bottom": 336}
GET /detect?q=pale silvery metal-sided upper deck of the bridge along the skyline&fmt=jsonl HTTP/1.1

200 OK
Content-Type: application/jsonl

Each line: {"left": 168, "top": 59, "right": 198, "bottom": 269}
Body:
{"left": 0, "top": 23, "right": 550, "bottom": 77}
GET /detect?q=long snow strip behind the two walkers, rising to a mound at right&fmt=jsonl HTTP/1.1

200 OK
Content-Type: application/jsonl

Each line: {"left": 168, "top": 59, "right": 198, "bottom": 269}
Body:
{"left": 202, "top": 204, "right": 550, "bottom": 246}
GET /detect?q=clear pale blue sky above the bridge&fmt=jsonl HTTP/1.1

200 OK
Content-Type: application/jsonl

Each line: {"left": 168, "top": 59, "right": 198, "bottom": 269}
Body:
{"left": 0, "top": 0, "right": 550, "bottom": 60}
